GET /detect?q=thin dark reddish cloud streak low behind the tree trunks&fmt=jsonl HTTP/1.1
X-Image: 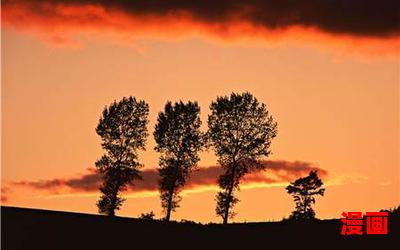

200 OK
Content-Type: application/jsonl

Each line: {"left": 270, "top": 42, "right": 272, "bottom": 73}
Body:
{"left": 12, "top": 161, "right": 327, "bottom": 193}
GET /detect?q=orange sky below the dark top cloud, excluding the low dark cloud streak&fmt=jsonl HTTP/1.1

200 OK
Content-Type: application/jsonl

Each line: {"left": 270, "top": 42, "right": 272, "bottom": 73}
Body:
{"left": 1, "top": 0, "right": 400, "bottom": 222}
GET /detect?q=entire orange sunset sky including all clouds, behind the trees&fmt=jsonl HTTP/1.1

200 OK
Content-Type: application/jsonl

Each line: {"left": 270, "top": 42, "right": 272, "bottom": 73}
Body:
{"left": 1, "top": 0, "right": 400, "bottom": 222}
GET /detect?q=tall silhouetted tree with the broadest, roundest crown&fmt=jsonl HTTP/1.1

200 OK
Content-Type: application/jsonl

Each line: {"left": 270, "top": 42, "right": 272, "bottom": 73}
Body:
{"left": 208, "top": 92, "right": 277, "bottom": 224}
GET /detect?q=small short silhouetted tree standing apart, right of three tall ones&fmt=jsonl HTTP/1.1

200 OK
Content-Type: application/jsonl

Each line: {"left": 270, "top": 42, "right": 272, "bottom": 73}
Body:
{"left": 286, "top": 170, "right": 325, "bottom": 220}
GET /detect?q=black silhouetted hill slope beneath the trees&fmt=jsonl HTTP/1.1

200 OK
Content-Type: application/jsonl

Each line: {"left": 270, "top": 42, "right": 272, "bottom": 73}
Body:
{"left": 1, "top": 206, "right": 400, "bottom": 250}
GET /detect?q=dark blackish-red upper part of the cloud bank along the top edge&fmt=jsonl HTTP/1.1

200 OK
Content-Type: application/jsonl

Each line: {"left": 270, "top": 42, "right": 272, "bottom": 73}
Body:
{"left": 2, "top": 0, "right": 400, "bottom": 37}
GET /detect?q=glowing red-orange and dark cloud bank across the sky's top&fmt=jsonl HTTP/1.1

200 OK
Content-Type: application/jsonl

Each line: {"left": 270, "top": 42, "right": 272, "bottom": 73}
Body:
{"left": 2, "top": 0, "right": 400, "bottom": 56}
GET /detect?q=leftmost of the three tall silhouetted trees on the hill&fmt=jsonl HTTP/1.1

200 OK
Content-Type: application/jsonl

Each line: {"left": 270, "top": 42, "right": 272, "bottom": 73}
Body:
{"left": 96, "top": 97, "right": 149, "bottom": 216}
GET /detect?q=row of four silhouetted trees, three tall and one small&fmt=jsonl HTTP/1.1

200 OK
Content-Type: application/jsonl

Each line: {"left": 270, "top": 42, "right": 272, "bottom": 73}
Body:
{"left": 96, "top": 92, "right": 324, "bottom": 224}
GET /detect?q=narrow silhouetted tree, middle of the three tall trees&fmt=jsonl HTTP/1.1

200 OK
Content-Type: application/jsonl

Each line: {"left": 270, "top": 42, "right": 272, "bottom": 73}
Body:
{"left": 154, "top": 102, "right": 203, "bottom": 221}
